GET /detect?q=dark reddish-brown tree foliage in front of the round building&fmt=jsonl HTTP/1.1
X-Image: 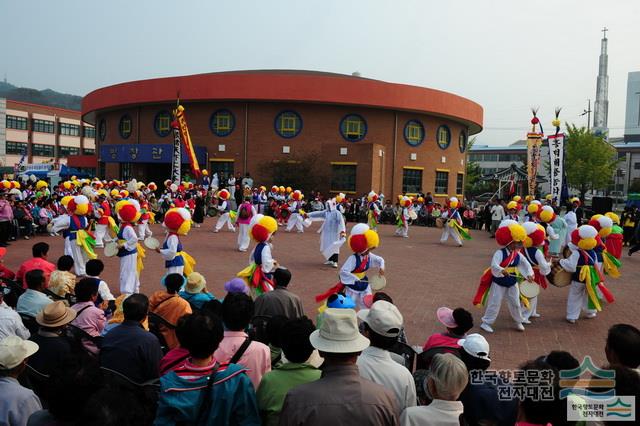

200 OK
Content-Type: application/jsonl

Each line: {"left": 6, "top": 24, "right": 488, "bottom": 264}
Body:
{"left": 260, "top": 152, "right": 328, "bottom": 194}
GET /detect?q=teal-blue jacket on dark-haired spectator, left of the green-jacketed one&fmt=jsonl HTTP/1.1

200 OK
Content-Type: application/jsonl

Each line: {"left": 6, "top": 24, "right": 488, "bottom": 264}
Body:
{"left": 153, "top": 364, "right": 261, "bottom": 426}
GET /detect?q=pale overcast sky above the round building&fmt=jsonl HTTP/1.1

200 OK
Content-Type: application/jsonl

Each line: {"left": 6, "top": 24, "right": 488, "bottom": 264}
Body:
{"left": 5, "top": 0, "right": 640, "bottom": 145}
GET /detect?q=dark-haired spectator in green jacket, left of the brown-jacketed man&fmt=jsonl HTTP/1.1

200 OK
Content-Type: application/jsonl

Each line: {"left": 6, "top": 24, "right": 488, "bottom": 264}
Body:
{"left": 257, "top": 317, "right": 321, "bottom": 426}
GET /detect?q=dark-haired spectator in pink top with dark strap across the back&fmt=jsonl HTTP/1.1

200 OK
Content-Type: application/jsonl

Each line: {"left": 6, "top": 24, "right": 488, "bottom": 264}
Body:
{"left": 214, "top": 293, "right": 271, "bottom": 389}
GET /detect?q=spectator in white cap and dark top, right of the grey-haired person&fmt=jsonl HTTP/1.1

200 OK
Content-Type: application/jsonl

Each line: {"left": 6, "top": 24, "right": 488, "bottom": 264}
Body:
{"left": 459, "top": 333, "right": 518, "bottom": 426}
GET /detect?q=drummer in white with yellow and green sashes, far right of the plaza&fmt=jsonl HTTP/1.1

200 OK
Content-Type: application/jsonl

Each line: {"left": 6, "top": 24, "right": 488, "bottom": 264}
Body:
{"left": 560, "top": 225, "right": 614, "bottom": 324}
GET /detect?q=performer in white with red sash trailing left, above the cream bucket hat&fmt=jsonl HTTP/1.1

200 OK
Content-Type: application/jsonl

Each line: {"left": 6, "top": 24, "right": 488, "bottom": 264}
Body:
{"left": 316, "top": 223, "right": 385, "bottom": 308}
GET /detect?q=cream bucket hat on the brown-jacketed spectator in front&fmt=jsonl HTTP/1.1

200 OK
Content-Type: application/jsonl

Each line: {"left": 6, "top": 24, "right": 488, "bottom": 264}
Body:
{"left": 309, "top": 308, "right": 369, "bottom": 354}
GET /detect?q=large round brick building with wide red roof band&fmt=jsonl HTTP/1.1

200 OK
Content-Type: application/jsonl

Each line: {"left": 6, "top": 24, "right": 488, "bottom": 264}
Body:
{"left": 82, "top": 71, "right": 483, "bottom": 201}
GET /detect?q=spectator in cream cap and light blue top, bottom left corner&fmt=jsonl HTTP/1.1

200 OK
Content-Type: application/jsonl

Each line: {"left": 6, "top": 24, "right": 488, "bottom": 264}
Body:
{"left": 0, "top": 336, "right": 42, "bottom": 426}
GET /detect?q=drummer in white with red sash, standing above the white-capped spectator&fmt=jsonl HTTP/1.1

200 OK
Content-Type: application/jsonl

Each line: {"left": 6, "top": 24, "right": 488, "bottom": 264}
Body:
{"left": 473, "top": 220, "right": 534, "bottom": 333}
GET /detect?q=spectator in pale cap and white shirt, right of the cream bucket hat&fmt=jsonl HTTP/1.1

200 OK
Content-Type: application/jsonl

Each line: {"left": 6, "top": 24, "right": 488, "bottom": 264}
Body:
{"left": 357, "top": 300, "right": 417, "bottom": 411}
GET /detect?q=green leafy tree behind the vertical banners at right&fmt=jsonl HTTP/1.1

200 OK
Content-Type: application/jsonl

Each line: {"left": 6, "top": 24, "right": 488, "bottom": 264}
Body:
{"left": 564, "top": 124, "right": 618, "bottom": 200}
